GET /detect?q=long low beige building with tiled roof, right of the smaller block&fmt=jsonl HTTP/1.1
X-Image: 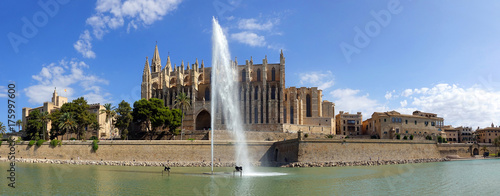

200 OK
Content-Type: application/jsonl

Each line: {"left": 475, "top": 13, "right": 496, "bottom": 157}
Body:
{"left": 363, "top": 111, "right": 443, "bottom": 139}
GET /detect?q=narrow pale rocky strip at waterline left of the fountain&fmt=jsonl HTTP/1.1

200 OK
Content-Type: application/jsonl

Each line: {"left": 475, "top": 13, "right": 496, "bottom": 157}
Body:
{"left": 0, "top": 158, "right": 260, "bottom": 167}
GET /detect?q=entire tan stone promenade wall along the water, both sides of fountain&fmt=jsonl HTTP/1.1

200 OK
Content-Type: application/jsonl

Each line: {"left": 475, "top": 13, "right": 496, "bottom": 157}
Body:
{"left": 0, "top": 138, "right": 496, "bottom": 165}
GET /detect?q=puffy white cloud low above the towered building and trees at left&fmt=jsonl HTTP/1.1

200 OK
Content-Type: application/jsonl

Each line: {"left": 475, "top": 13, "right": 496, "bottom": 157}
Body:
{"left": 23, "top": 59, "right": 110, "bottom": 105}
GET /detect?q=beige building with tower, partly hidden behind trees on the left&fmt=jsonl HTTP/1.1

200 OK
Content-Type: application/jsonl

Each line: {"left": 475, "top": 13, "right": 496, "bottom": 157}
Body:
{"left": 22, "top": 89, "right": 114, "bottom": 139}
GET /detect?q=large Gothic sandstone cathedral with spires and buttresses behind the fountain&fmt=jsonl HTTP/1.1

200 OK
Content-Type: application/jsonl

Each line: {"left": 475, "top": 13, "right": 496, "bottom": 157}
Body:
{"left": 141, "top": 46, "right": 335, "bottom": 134}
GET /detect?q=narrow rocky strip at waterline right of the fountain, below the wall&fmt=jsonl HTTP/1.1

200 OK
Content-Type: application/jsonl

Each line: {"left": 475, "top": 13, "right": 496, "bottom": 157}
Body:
{"left": 281, "top": 158, "right": 450, "bottom": 167}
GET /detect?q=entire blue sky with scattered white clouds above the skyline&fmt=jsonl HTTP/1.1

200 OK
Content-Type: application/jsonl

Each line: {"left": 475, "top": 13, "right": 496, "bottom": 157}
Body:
{"left": 0, "top": 0, "right": 500, "bottom": 131}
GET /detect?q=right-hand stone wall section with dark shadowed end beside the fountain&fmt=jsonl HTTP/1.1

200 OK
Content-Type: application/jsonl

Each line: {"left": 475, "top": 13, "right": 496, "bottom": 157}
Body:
{"left": 274, "top": 139, "right": 442, "bottom": 163}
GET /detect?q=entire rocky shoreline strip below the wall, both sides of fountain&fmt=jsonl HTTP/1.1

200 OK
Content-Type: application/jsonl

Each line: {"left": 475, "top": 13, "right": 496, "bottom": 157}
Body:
{"left": 0, "top": 158, "right": 450, "bottom": 167}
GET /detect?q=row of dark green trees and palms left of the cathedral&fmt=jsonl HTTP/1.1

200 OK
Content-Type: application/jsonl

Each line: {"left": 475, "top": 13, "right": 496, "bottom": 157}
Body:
{"left": 19, "top": 93, "right": 190, "bottom": 140}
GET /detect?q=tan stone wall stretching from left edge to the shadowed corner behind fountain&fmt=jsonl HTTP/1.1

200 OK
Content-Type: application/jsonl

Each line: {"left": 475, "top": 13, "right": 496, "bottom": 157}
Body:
{"left": 0, "top": 140, "right": 273, "bottom": 162}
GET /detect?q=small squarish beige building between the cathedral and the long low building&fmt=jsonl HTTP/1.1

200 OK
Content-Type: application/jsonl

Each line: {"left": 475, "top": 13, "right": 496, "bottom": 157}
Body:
{"left": 335, "top": 111, "right": 363, "bottom": 136}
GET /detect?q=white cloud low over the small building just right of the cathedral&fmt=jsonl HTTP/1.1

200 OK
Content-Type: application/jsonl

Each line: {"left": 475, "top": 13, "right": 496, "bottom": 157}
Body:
{"left": 330, "top": 88, "right": 388, "bottom": 119}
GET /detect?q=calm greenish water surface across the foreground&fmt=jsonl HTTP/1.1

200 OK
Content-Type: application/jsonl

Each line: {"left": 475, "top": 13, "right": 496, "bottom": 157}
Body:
{"left": 0, "top": 159, "right": 500, "bottom": 195}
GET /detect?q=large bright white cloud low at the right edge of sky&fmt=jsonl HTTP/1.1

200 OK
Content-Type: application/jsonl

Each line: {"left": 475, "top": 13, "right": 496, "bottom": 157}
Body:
{"left": 405, "top": 84, "right": 500, "bottom": 127}
